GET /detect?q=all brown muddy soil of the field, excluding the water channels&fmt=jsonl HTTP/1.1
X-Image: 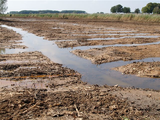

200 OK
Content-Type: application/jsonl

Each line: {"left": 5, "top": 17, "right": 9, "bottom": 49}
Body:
{"left": 0, "top": 18, "right": 160, "bottom": 120}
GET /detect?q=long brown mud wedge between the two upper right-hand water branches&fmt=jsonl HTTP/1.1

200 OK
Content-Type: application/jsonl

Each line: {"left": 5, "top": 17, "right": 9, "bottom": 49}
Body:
{"left": 71, "top": 44, "right": 160, "bottom": 64}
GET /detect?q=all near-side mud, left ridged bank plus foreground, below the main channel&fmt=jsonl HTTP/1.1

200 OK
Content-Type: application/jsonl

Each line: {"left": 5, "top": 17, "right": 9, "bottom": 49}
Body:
{"left": 0, "top": 52, "right": 160, "bottom": 120}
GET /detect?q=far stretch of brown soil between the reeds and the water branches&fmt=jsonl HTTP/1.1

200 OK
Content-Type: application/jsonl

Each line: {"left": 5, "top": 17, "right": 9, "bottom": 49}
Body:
{"left": 2, "top": 18, "right": 160, "bottom": 44}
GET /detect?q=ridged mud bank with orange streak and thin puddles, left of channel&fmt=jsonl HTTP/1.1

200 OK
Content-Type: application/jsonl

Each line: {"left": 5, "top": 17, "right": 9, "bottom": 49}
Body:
{"left": 0, "top": 52, "right": 80, "bottom": 80}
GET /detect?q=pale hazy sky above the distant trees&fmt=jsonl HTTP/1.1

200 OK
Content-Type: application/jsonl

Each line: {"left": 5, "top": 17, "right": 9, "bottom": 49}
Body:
{"left": 7, "top": 0, "right": 160, "bottom": 13}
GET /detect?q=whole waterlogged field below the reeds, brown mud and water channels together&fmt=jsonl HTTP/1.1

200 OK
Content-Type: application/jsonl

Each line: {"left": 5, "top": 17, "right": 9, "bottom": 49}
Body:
{"left": 0, "top": 18, "right": 160, "bottom": 120}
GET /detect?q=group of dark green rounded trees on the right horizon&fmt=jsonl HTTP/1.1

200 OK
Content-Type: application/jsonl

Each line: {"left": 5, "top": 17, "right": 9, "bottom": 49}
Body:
{"left": 110, "top": 3, "right": 160, "bottom": 14}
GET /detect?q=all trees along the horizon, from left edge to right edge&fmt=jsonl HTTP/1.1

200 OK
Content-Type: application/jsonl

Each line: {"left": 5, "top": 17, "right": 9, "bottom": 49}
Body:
{"left": 0, "top": 0, "right": 160, "bottom": 14}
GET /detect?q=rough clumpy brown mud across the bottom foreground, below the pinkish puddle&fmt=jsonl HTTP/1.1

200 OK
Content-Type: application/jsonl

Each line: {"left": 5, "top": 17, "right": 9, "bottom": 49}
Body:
{"left": 0, "top": 77, "right": 160, "bottom": 120}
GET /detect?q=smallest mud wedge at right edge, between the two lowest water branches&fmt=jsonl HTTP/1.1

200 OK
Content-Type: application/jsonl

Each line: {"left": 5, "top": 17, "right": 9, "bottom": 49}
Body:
{"left": 113, "top": 62, "right": 160, "bottom": 78}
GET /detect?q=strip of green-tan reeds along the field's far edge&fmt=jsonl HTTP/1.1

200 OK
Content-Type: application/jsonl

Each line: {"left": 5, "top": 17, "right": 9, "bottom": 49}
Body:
{"left": 0, "top": 14, "right": 160, "bottom": 22}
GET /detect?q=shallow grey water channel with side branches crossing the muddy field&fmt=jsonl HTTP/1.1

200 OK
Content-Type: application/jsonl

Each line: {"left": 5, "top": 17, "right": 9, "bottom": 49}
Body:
{"left": 1, "top": 25, "right": 160, "bottom": 89}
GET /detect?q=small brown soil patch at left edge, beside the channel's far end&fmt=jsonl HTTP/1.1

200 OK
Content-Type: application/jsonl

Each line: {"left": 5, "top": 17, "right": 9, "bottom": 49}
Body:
{"left": 0, "top": 26, "right": 27, "bottom": 49}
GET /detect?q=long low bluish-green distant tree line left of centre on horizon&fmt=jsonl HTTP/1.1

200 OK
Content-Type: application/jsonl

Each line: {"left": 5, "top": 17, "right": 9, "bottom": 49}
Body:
{"left": 10, "top": 10, "right": 86, "bottom": 14}
